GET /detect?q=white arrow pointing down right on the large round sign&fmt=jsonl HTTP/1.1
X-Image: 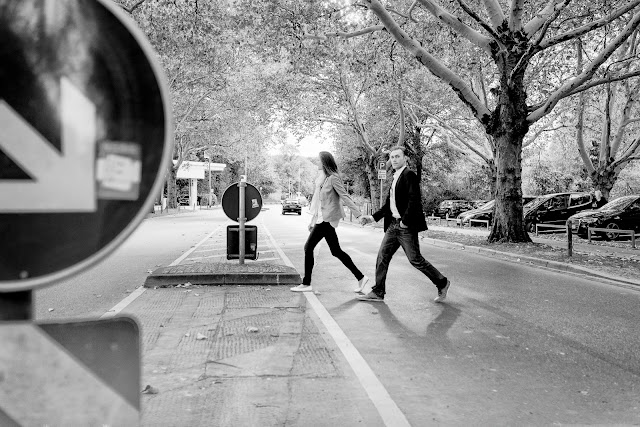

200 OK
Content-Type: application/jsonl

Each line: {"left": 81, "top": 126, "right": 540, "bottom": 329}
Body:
{"left": 0, "top": 78, "right": 96, "bottom": 213}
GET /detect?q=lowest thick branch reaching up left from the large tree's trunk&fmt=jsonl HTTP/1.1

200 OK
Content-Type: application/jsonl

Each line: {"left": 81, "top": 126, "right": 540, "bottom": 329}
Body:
{"left": 368, "top": 0, "right": 491, "bottom": 124}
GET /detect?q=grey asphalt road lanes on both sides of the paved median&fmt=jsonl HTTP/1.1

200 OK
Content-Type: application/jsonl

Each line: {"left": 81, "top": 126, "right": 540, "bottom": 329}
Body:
{"left": 35, "top": 205, "right": 640, "bottom": 425}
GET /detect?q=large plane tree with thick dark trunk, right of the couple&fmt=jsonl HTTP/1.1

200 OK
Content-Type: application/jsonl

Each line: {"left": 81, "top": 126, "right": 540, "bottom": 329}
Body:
{"left": 312, "top": 0, "right": 640, "bottom": 242}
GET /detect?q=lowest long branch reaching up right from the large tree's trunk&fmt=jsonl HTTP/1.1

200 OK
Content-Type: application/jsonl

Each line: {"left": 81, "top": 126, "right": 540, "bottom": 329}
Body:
{"left": 527, "top": 10, "right": 640, "bottom": 123}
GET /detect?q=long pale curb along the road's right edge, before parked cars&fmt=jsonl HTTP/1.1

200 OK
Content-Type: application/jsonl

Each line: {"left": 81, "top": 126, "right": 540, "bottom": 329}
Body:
{"left": 420, "top": 237, "right": 640, "bottom": 286}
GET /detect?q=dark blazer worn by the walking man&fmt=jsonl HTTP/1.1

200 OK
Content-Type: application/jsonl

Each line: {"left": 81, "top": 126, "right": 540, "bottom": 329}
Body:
{"left": 372, "top": 168, "right": 427, "bottom": 233}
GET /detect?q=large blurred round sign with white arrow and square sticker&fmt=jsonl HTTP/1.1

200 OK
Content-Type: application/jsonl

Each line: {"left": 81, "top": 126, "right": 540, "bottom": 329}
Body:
{"left": 0, "top": 0, "right": 173, "bottom": 292}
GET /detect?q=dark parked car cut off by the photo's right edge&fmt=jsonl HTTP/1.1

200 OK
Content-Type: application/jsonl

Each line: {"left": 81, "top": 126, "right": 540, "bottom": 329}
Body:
{"left": 569, "top": 195, "right": 640, "bottom": 240}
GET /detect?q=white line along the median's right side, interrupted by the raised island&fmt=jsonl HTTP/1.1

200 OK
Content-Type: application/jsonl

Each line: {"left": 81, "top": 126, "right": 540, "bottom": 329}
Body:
{"left": 263, "top": 224, "right": 411, "bottom": 427}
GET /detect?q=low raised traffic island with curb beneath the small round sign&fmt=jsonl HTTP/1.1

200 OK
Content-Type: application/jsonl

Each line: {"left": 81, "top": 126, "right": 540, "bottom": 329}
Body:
{"left": 144, "top": 262, "right": 302, "bottom": 288}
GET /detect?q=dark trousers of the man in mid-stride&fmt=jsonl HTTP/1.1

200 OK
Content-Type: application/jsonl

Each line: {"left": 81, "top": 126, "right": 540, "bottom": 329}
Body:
{"left": 372, "top": 219, "right": 447, "bottom": 297}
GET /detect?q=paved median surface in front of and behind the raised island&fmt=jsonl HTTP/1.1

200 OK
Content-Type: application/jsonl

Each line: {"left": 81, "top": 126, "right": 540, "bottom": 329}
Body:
{"left": 123, "top": 228, "right": 384, "bottom": 427}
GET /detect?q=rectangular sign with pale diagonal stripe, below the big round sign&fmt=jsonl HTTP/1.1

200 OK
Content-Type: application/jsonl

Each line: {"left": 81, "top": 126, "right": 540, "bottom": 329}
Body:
{"left": 0, "top": 317, "right": 141, "bottom": 426}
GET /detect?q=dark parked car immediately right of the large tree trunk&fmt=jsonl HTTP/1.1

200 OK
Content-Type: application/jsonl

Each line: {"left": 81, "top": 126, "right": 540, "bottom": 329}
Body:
{"left": 524, "top": 193, "right": 593, "bottom": 232}
